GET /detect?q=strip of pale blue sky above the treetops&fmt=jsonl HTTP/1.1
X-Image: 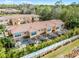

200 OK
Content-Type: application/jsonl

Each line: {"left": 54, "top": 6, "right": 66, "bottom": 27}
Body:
{"left": 0, "top": 0, "right": 79, "bottom": 5}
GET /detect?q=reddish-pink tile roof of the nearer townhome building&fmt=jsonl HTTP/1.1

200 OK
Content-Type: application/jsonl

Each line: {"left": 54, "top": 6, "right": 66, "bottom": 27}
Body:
{"left": 8, "top": 20, "right": 63, "bottom": 33}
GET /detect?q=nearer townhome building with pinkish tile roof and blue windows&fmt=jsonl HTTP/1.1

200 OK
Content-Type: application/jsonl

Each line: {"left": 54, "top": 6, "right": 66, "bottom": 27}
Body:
{"left": 7, "top": 20, "right": 64, "bottom": 40}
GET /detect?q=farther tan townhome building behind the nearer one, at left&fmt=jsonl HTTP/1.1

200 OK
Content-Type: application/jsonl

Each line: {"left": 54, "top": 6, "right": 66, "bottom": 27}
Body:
{"left": 0, "top": 14, "right": 39, "bottom": 26}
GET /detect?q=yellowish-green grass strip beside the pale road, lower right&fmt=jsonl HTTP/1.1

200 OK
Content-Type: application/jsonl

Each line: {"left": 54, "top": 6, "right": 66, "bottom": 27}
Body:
{"left": 42, "top": 39, "right": 79, "bottom": 58}
